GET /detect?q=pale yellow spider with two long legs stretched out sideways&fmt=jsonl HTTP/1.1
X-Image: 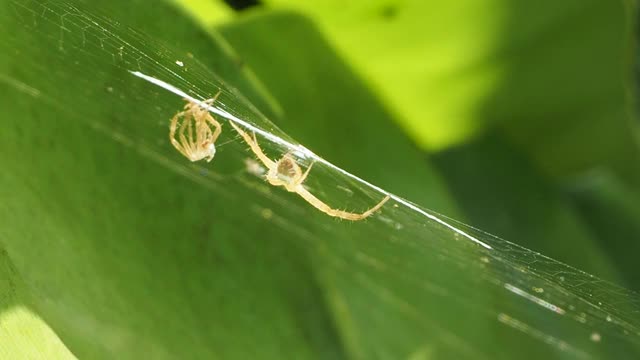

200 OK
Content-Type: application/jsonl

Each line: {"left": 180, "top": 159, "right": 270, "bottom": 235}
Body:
{"left": 230, "top": 122, "right": 389, "bottom": 221}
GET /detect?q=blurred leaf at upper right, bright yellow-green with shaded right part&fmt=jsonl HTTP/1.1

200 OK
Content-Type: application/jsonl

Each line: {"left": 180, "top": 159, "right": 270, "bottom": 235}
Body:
{"left": 263, "top": 0, "right": 640, "bottom": 186}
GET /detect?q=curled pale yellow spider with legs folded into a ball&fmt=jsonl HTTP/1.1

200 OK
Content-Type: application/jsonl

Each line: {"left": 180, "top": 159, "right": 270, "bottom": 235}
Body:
{"left": 169, "top": 91, "right": 222, "bottom": 162}
